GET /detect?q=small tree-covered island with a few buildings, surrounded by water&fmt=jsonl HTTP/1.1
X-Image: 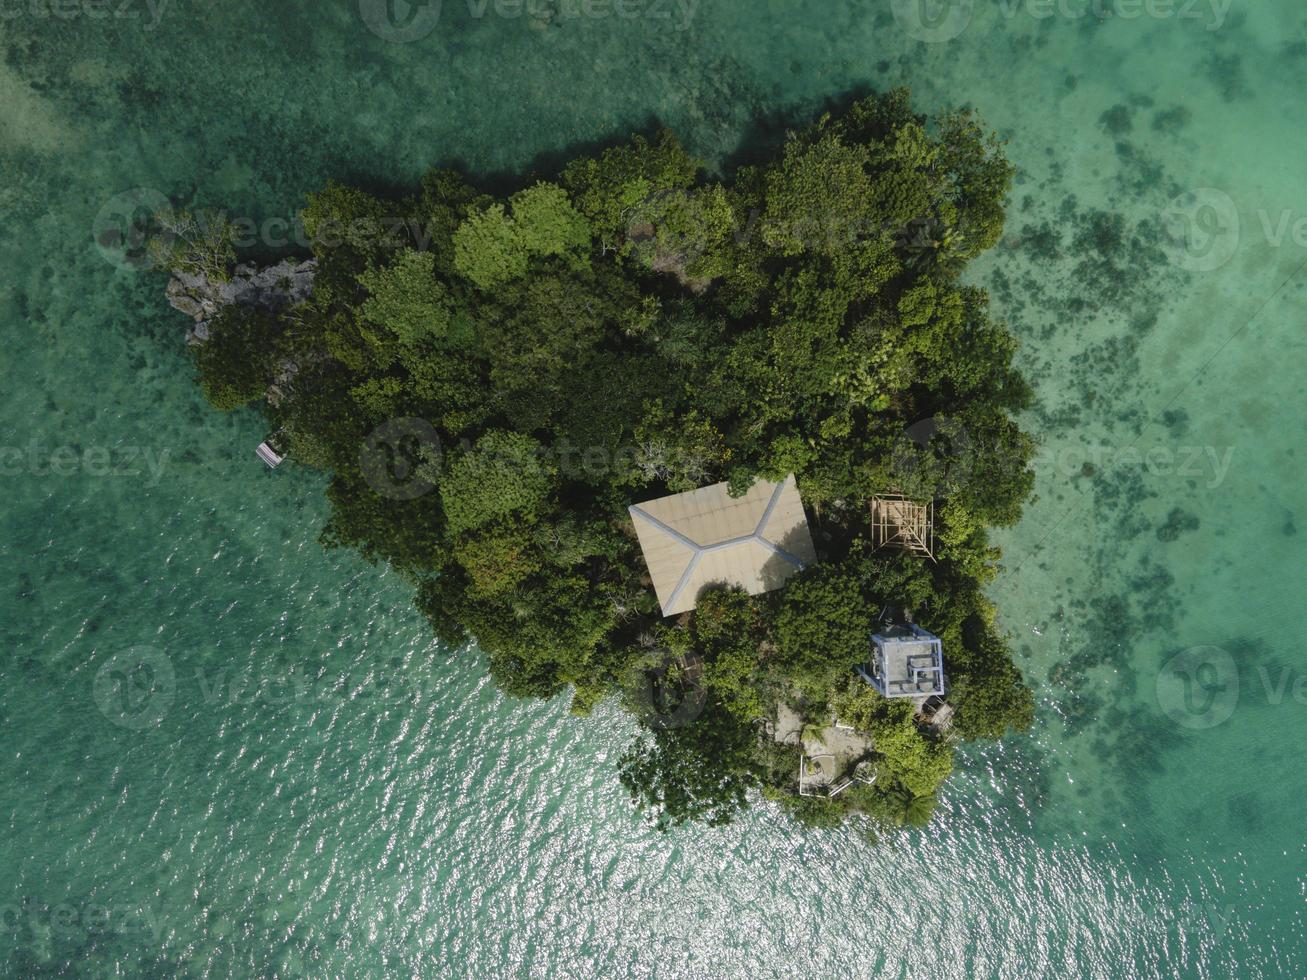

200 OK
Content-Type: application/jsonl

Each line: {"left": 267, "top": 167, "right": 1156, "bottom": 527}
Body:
{"left": 157, "top": 90, "right": 1034, "bottom": 828}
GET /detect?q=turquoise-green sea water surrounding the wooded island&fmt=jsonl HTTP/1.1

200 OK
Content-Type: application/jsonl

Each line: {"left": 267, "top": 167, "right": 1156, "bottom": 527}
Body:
{"left": 0, "top": 0, "right": 1307, "bottom": 977}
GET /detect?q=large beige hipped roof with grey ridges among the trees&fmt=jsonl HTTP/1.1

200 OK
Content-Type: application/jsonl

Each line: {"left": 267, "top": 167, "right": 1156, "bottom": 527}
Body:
{"left": 630, "top": 474, "right": 817, "bottom": 615}
